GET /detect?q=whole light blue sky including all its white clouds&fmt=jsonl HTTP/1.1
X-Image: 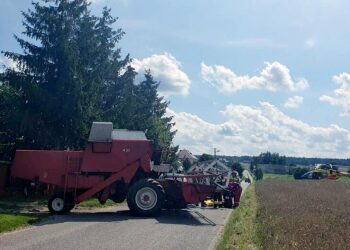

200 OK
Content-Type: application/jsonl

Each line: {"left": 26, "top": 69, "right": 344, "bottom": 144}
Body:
{"left": 0, "top": 0, "right": 350, "bottom": 158}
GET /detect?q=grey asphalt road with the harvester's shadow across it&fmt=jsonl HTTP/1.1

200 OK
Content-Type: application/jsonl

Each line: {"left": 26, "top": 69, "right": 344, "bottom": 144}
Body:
{"left": 0, "top": 174, "right": 247, "bottom": 250}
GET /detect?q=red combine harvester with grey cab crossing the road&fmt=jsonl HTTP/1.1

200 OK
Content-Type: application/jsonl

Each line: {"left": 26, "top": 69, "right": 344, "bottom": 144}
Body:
{"left": 11, "top": 122, "right": 216, "bottom": 215}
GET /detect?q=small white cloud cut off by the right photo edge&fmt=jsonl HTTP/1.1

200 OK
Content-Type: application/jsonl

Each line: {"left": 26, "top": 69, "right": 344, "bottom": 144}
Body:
{"left": 320, "top": 73, "right": 350, "bottom": 116}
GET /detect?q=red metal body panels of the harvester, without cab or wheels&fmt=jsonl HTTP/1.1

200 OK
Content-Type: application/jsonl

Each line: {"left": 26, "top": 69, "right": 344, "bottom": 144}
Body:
{"left": 12, "top": 140, "right": 152, "bottom": 202}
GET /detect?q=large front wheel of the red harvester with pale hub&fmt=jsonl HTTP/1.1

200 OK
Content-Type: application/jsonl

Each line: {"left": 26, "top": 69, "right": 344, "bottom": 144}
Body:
{"left": 126, "top": 179, "right": 165, "bottom": 216}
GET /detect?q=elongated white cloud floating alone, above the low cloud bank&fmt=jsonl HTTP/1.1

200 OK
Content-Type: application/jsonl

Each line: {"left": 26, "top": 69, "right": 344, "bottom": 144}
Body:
{"left": 201, "top": 61, "right": 309, "bottom": 93}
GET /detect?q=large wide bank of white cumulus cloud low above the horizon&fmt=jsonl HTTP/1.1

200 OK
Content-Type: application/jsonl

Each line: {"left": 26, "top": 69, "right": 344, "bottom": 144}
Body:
{"left": 168, "top": 102, "right": 350, "bottom": 158}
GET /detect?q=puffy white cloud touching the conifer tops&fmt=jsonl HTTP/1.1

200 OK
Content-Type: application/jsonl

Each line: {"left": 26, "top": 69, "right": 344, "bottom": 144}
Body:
{"left": 131, "top": 53, "right": 191, "bottom": 96}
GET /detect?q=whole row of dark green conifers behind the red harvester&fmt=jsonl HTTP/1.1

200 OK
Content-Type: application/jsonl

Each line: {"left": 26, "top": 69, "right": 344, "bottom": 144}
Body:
{"left": 0, "top": 0, "right": 177, "bottom": 162}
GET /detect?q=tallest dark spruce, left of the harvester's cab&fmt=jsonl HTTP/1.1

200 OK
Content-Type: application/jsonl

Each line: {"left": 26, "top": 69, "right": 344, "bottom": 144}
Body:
{"left": 0, "top": 0, "right": 129, "bottom": 156}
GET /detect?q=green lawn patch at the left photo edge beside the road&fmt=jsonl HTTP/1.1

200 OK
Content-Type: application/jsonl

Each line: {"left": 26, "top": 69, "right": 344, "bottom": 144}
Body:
{"left": 0, "top": 213, "right": 47, "bottom": 233}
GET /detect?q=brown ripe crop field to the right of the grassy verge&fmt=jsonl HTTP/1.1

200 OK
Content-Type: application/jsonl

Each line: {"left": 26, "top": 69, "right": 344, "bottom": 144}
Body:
{"left": 256, "top": 180, "right": 350, "bottom": 249}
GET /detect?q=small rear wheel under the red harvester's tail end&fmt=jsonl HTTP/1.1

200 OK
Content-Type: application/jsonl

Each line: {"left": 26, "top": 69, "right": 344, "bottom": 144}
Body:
{"left": 48, "top": 193, "right": 74, "bottom": 214}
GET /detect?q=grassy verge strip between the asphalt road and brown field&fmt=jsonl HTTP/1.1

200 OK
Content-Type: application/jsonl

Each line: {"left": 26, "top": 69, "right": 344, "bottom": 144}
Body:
{"left": 216, "top": 184, "right": 260, "bottom": 250}
